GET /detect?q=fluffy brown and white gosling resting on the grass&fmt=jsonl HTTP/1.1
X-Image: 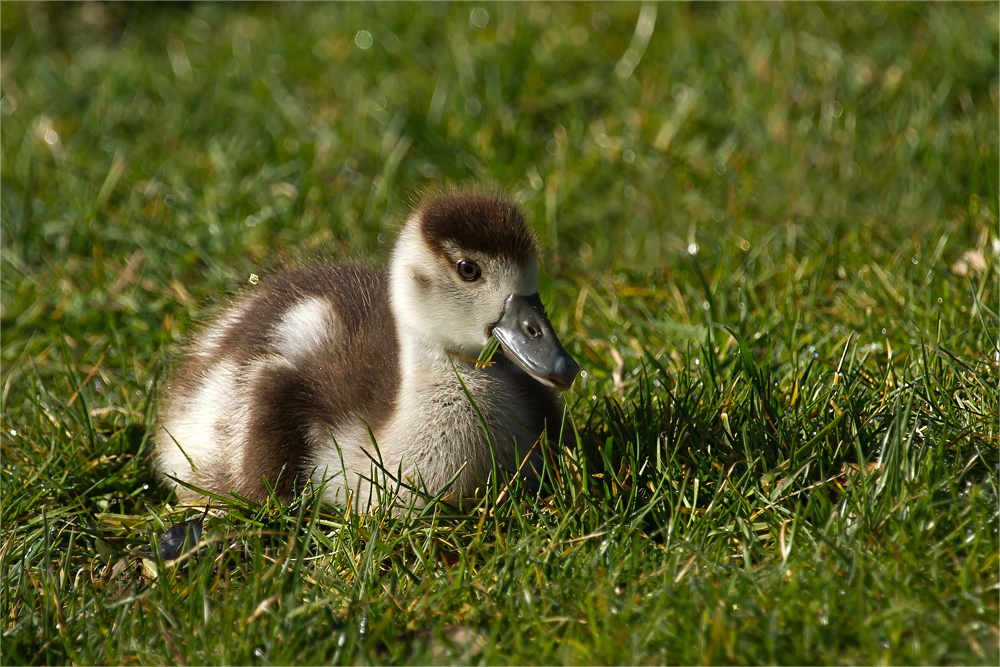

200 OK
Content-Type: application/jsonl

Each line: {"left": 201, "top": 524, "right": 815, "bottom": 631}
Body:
{"left": 154, "top": 191, "right": 579, "bottom": 512}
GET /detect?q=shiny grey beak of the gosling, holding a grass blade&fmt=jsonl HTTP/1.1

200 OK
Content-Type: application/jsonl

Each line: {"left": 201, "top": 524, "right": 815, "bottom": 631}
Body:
{"left": 492, "top": 293, "right": 580, "bottom": 391}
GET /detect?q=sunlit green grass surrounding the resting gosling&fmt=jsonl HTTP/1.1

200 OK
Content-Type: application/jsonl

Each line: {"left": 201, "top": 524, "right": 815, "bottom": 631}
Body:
{"left": 0, "top": 3, "right": 1000, "bottom": 665}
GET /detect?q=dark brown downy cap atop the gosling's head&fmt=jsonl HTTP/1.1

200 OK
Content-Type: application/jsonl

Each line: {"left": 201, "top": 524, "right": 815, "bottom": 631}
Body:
{"left": 417, "top": 192, "right": 538, "bottom": 264}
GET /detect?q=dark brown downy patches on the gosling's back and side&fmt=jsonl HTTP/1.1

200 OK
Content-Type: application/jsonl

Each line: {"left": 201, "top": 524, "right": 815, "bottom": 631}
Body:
{"left": 168, "top": 266, "right": 400, "bottom": 498}
